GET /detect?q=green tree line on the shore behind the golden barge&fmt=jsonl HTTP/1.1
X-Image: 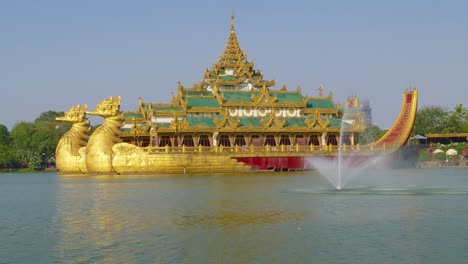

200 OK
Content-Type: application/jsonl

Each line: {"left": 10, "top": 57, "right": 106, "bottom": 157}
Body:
{"left": 0, "top": 104, "right": 468, "bottom": 169}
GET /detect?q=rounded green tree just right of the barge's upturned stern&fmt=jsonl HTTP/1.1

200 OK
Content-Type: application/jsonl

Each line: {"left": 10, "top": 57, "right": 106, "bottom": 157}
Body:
{"left": 413, "top": 106, "right": 449, "bottom": 135}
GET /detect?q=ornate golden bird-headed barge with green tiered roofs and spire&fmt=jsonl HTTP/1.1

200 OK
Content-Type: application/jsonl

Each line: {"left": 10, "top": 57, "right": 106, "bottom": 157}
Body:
{"left": 56, "top": 16, "right": 418, "bottom": 174}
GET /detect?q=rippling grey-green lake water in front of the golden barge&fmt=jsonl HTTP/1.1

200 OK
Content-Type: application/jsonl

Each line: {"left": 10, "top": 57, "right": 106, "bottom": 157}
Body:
{"left": 0, "top": 169, "right": 468, "bottom": 264}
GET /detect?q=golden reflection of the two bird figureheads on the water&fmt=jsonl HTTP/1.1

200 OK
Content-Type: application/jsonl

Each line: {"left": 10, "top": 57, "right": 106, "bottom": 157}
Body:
{"left": 54, "top": 175, "right": 140, "bottom": 263}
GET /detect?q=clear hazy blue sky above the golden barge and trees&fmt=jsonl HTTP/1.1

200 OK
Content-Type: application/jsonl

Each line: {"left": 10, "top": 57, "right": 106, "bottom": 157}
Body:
{"left": 0, "top": 0, "right": 468, "bottom": 130}
